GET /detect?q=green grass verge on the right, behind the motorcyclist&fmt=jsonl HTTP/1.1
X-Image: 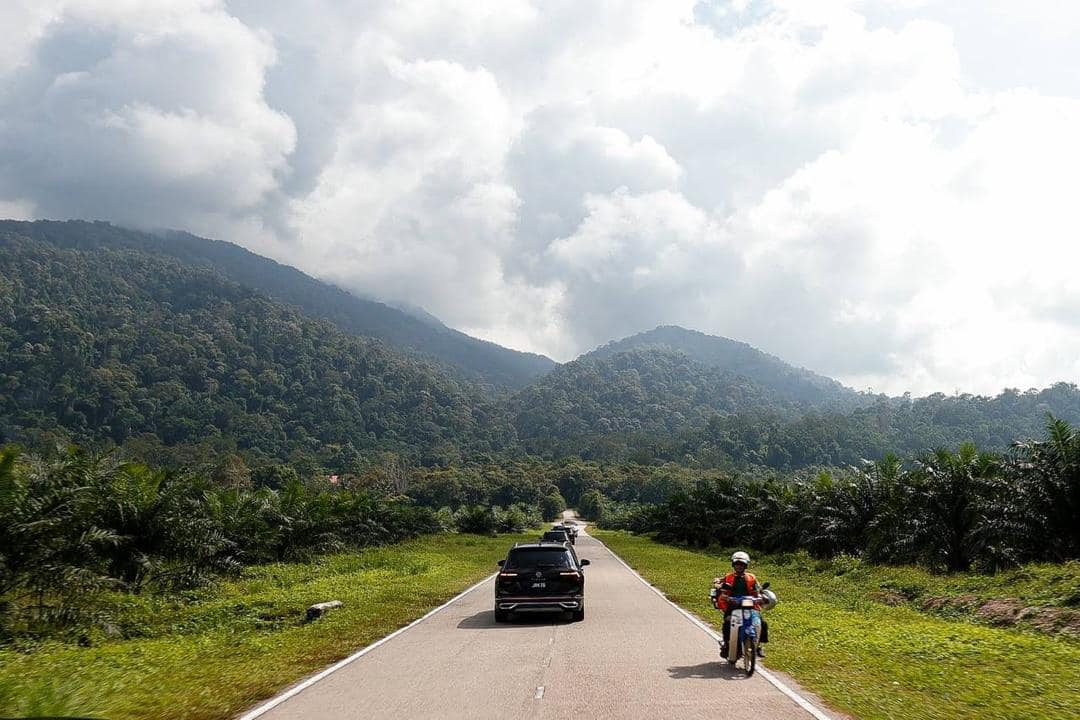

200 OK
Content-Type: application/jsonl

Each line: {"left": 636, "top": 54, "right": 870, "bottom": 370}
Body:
{"left": 591, "top": 530, "right": 1080, "bottom": 720}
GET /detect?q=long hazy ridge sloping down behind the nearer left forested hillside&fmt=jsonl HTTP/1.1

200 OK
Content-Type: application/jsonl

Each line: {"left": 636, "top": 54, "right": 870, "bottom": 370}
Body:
{"left": 0, "top": 220, "right": 555, "bottom": 389}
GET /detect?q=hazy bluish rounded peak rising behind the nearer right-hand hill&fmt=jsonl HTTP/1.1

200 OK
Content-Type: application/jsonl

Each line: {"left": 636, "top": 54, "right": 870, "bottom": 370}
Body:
{"left": 579, "top": 325, "right": 874, "bottom": 411}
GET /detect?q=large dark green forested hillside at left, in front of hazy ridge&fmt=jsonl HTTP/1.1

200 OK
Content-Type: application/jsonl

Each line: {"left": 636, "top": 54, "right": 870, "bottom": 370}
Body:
{"left": 0, "top": 226, "right": 512, "bottom": 462}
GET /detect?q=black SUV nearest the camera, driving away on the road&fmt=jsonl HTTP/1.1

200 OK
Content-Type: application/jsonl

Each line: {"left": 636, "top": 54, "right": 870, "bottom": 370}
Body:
{"left": 495, "top": 542, "right": 589, "bottom": 623}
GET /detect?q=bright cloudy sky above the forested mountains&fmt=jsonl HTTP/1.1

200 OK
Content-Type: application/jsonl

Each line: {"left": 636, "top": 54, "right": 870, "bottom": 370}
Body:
{"left": 0, "top": 0, "right": 1080, "bottom": 395}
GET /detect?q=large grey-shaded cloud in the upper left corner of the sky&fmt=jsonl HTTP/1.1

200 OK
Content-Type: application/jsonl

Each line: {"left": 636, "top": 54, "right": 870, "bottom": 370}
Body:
{"left": 0, "top": 2, "right": 295, "bottom": 231}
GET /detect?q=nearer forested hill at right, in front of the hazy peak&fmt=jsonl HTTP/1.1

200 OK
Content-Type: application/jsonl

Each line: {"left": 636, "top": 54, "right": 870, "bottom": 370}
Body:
{"left": 511, "top": 343, "right": 1080, "bottom": 468}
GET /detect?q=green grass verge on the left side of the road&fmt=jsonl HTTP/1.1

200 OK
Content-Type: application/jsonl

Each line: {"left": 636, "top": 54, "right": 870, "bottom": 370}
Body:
{"left": 0, "top": 532, "right": 535, "bottom": 720}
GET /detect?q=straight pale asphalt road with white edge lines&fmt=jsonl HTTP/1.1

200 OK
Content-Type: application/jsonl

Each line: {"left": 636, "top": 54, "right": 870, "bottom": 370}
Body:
{"left": 252, "top": 526, "right": 825, "bottom": 720}
